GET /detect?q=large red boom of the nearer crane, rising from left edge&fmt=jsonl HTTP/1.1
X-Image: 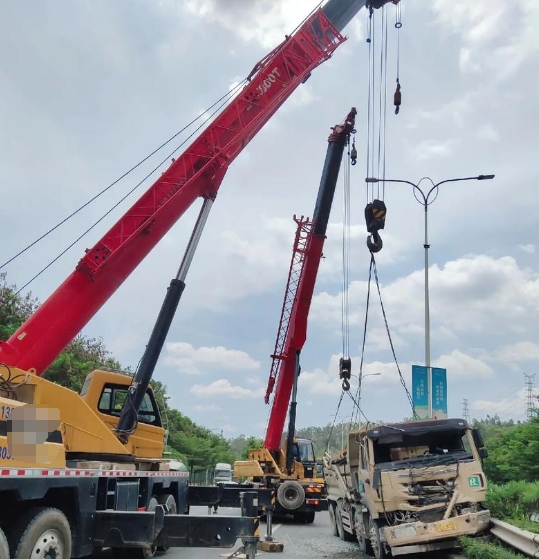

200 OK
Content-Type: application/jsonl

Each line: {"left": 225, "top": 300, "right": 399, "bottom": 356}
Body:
{"left": 0, "top": 0, "right": 363, "bottom": 376}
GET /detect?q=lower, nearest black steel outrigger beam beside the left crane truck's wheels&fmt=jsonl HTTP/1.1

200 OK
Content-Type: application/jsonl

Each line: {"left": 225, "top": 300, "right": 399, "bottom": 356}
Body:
{"left": 92, "top": 506, "right": 260, "bottom": 548}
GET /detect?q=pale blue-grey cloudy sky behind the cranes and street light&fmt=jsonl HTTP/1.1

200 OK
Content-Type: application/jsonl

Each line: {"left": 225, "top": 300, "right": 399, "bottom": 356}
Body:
{"left": 0, "top": 0, "right": 539, "bottom": 437}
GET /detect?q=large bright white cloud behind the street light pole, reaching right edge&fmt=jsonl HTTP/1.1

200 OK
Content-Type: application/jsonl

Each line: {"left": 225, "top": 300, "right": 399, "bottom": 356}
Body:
{"left": 311, "top": 255, "right": 539, "bottom": 340}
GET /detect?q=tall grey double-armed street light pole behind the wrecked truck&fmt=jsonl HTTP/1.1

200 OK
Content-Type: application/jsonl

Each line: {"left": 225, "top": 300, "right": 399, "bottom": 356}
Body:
{"left": 365, "top": 175, "right": 494, "bottom": 418}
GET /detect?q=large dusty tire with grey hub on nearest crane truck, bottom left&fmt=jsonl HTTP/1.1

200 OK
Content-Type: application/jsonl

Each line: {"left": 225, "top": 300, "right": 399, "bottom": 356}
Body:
{"left": 10, "top": 507, "right": 72, "bottom": 559}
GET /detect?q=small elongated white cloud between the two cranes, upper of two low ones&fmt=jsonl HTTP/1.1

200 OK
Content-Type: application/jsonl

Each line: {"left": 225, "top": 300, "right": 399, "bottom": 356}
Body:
{"left": 164, "top": 342, "right": 260, "bottom": 375}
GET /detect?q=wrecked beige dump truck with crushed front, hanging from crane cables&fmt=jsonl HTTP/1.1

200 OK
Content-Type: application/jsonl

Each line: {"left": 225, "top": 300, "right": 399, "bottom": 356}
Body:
{"left": 324, "top": 419, "right": 490, "bottom": 559}
